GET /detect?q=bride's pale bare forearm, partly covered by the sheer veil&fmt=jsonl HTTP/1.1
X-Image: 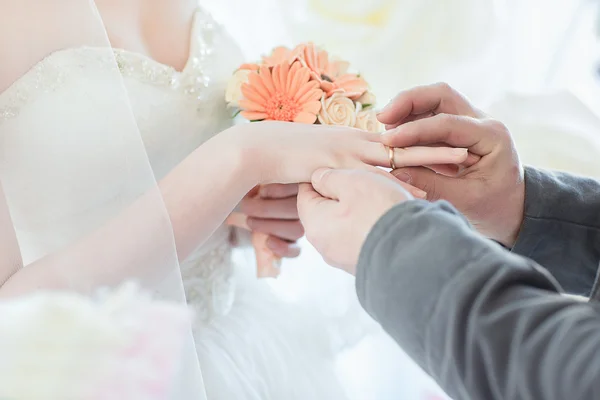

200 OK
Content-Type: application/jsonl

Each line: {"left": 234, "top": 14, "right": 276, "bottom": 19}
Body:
{"left": 0, "top": 128, "right": 260, "bottom": 297}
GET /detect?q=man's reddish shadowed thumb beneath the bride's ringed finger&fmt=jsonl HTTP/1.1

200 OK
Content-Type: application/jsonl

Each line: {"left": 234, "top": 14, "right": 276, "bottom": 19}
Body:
{"left": 392, "top": 167, "right": 466, "bottom": 204}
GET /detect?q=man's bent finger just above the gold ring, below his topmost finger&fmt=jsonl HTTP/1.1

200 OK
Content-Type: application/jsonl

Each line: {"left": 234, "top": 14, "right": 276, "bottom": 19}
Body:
{"left": 381, "top": 114, "right": 495, "bottom": 156}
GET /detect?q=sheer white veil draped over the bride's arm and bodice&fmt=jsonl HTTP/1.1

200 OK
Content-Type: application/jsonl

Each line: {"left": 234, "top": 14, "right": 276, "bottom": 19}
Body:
{"left": 0, "top": 0, "right": 206, "bottom": 400}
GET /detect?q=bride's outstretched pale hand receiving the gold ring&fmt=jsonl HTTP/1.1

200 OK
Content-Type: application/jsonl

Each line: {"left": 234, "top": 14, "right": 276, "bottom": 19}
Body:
{"left": 233, "top": 121, "right": 468, "bottom": 191}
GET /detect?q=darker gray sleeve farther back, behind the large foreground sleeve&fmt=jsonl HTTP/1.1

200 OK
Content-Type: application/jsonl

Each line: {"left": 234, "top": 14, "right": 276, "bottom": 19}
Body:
{"left": 512, "top": 168, "right": 600, "bottom": 295}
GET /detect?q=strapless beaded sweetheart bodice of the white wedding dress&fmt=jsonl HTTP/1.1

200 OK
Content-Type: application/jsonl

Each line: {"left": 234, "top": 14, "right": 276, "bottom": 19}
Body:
{"left": 0, "top": 10, "right": 241, "bottom": 321}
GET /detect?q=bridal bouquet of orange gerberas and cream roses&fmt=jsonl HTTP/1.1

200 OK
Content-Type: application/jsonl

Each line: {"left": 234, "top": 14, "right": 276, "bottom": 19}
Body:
{"left": 225, "top": 43, "right": 382, "bottom": 276}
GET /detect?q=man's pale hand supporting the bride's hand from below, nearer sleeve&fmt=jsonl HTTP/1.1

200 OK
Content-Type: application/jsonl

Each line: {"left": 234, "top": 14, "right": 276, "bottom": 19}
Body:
{"left": 298, "top": 169, "right": 412, "bottom": 274}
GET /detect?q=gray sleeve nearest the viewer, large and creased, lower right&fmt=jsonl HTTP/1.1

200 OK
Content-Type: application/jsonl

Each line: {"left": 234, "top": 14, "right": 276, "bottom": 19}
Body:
{"left": 356, "top": 201, "right": 600, "bottom": 400}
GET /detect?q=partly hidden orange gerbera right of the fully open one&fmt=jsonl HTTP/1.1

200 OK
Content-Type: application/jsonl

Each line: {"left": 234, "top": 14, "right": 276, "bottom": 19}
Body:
{"left": 299, "top": 43, "right": 369, "bottom": 100}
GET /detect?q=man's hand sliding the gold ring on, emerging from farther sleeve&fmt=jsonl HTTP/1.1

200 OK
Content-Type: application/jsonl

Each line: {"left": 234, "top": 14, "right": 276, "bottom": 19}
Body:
{"left": 378, "top": 84, "right": 525, "bottom": 247}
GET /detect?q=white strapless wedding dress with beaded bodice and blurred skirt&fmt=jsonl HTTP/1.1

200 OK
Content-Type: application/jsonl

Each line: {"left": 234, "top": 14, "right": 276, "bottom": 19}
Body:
{"left": 0, "top": 7, "right": 396, "bottom": 400}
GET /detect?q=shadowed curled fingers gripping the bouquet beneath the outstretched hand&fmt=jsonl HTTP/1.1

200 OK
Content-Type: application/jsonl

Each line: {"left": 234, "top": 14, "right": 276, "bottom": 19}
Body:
{"left": 240, "top": 184, "right": 304, "bottom": 258}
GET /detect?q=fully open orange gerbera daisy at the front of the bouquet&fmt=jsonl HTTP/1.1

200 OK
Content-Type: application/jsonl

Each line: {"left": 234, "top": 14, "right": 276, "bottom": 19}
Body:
{"left": 240, "top": 61, "right": 323, "bottom": 124}
